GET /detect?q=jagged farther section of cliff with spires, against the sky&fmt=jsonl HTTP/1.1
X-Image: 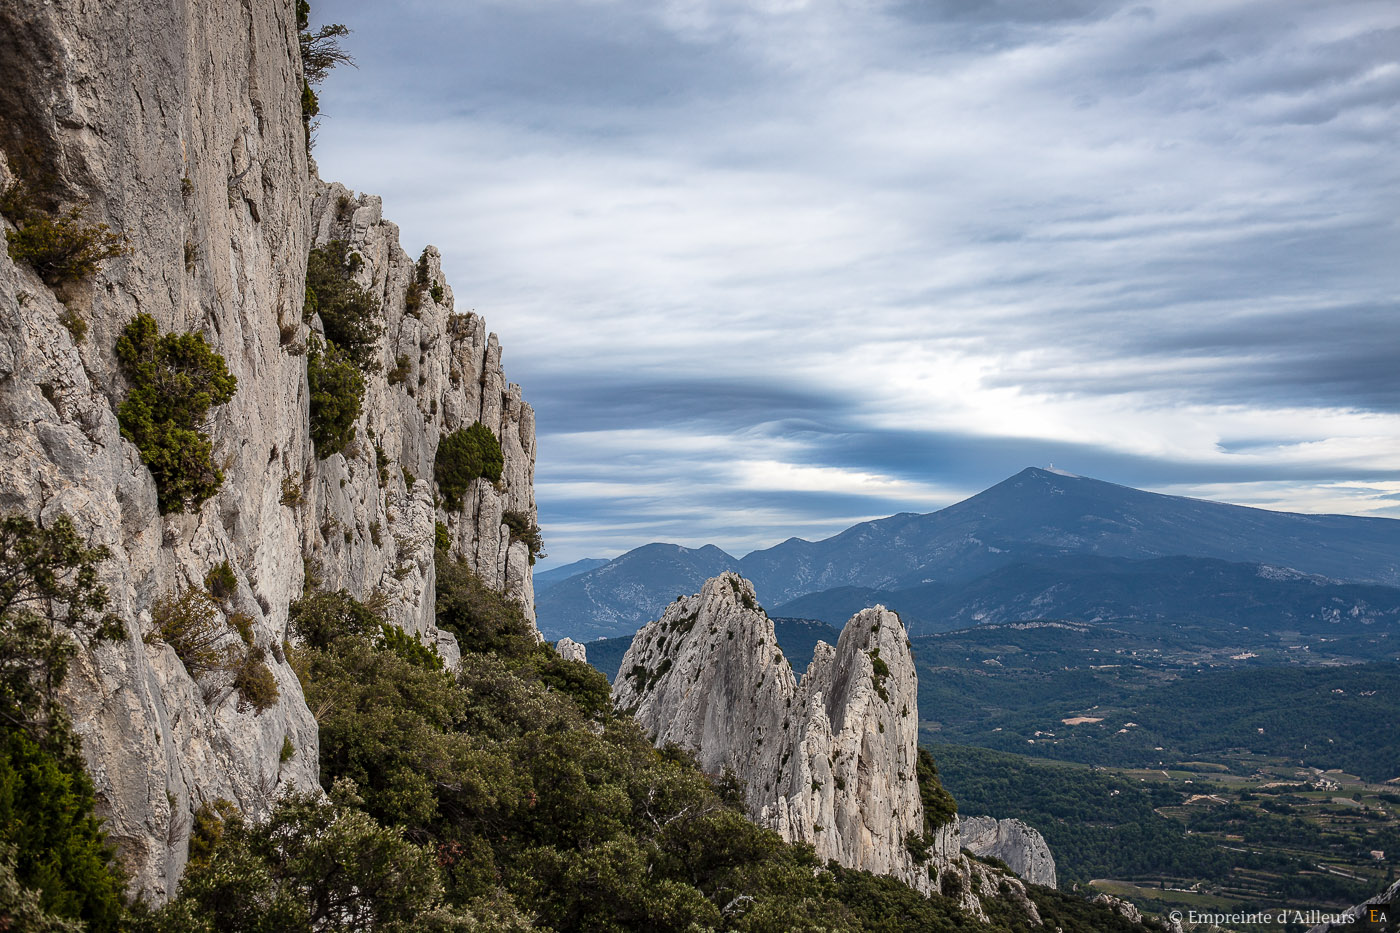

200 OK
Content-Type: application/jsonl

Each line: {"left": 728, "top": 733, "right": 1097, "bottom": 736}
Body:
{"left": 295, "top": 184, "right": 536, "bottom": 656}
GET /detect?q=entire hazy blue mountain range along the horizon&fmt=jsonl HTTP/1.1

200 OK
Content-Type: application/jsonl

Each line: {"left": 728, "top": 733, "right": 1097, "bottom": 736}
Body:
{"left": 536, "top": 468, "right": 1400, "bottom": 640}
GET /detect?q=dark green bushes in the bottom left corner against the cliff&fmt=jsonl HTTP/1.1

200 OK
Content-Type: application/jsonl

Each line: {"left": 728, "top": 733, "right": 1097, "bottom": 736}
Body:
{"left": 0, "top": 516, "right": 125, "bottom": 932}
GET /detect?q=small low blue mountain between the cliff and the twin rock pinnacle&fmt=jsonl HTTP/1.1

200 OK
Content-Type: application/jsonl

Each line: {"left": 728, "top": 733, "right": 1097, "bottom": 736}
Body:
{"left": 535, "top": 544, "right": 739, "bottom": 642}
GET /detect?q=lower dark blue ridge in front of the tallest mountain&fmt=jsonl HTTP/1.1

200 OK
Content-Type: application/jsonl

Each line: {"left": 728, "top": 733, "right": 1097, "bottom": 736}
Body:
{"left": 774, "top": 555, "right": 1400, "bottom": 635}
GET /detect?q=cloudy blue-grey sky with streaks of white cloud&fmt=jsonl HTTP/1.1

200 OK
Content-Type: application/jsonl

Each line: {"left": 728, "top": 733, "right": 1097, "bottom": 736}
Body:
{"left": 312, "top": 0, "right": 1400, "bottom": 566}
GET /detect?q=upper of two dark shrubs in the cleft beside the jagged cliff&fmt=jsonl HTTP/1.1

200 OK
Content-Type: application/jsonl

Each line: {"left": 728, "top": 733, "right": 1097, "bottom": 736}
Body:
{"left": 307, "top": 240, "right": 384, "bottom": 373}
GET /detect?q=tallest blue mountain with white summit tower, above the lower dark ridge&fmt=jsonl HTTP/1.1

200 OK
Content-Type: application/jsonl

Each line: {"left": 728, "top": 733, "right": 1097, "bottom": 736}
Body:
{"left": 741, "top": 468, "right": 1400, "bottom": 605}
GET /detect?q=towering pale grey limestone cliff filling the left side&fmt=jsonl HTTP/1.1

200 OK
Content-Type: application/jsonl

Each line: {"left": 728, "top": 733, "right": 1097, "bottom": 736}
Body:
{"left": 0, "top": 0, "right": 535, "bottom": 898}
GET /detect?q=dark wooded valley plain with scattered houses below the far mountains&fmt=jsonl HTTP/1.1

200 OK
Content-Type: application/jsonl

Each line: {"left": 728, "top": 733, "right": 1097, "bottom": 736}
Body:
{"left": 913, "top": 623, "right": 1400, "bottom": 780}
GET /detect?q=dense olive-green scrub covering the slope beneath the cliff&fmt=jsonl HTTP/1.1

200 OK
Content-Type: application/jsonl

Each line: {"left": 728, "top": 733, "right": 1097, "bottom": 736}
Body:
{"left": 131, "top": 552, "right": 1133, "bottom": 933}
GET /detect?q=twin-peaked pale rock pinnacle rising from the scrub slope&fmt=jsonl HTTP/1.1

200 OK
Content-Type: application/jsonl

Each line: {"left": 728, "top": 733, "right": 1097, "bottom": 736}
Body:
{"left": 613, "top": 573, "right": 959, "bottom": 891}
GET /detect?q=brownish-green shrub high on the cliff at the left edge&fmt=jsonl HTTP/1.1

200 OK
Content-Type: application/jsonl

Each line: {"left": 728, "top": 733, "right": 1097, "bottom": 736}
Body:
{"left": 0, "top": 182, "right": 130, "bottom": 287}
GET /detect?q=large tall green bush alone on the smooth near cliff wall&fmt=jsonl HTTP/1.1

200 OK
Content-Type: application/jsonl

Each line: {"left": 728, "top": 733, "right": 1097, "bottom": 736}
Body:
{"left": 116, "top": 314, "right": 238, "bottom": 513}
